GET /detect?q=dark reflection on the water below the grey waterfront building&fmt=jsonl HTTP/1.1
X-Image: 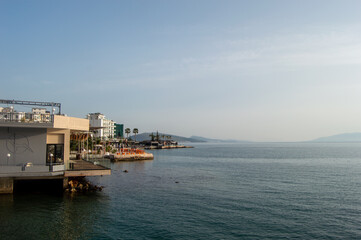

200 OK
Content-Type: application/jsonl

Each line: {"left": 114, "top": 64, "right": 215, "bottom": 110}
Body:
{"left": 0, "top": 193, "right": 109, "bottom": 239}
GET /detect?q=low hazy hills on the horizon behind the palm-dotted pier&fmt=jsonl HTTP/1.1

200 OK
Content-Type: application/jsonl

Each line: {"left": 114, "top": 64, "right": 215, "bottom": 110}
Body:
{"left": 129, "top": 132, "right": 249, "bottom": 143}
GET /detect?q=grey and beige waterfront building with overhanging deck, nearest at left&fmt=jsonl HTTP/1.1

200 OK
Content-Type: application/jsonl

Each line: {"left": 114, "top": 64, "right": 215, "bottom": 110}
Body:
{"left": 0, "top": 111, "right": 110, "bottom": 193}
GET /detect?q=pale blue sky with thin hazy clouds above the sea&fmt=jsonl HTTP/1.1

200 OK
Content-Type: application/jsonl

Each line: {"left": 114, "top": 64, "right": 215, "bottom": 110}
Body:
{"left": 0, "top": 0, "right": 361, "bottom": 142}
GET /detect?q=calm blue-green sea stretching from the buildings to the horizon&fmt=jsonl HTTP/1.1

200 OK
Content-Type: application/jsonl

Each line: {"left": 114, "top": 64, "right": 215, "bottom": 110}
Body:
{"left": 0, "top": 143, "right": 361, "bottom": 239}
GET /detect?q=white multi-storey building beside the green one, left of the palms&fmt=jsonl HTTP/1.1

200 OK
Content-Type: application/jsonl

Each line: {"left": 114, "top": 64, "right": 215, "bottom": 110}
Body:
{"left": 87, "top": 113, "right": 115, "bottom": 139}
